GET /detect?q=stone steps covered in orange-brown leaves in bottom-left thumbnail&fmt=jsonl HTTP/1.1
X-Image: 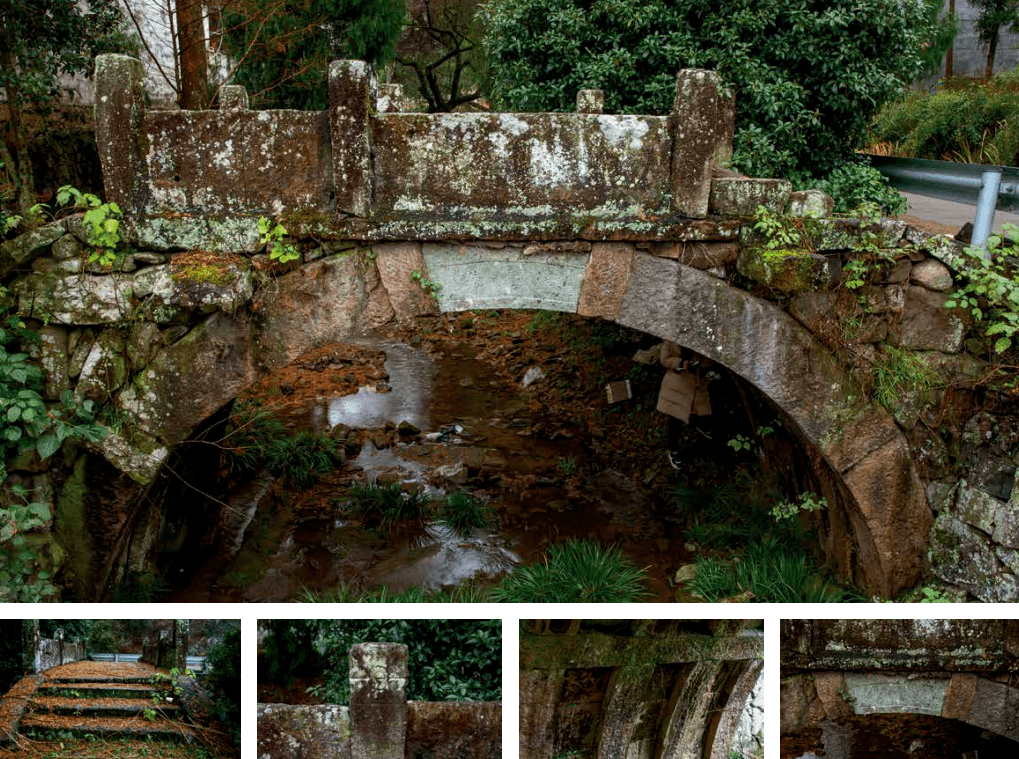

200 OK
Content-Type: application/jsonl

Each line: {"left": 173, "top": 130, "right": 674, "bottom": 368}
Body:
{"left": 0, "top": 661, "right": 197, "bottom": 745}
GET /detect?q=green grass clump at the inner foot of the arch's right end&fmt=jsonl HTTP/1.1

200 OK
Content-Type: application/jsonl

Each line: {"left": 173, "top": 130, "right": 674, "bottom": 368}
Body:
{"left": 687, "top": 544, "right": 861, "bottom": 603}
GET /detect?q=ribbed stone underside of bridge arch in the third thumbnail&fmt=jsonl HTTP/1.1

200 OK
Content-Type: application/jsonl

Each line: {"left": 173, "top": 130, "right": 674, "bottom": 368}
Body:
{"left": 520, "top": 619, "right": 764, "bottom": 759}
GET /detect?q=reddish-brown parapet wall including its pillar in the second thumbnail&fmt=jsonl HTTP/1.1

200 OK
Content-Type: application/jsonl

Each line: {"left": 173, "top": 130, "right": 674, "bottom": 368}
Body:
{"left": 258, "top": 643, "right": 502, "bottom": 759}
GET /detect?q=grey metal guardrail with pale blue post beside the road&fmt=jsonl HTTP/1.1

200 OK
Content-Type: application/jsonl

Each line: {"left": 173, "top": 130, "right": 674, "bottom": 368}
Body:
{"left": 868, "top": 156, "right": 1019, "bottom": 246}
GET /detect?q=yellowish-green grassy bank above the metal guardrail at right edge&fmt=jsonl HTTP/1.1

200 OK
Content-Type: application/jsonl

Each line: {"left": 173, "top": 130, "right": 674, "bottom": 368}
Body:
{"left": 870, "top": 71, "right": 1019, "bottom": 166}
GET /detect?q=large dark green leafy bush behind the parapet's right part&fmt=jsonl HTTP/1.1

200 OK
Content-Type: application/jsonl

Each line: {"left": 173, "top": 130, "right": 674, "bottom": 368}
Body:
{"left": 485, "top": 0, "right": 941, "bottom": 179}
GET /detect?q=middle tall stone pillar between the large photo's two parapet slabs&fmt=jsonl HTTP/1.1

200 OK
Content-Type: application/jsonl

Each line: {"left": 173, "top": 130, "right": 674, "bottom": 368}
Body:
{"left": 329, "top": 60, "right": 378, "bottom": 218}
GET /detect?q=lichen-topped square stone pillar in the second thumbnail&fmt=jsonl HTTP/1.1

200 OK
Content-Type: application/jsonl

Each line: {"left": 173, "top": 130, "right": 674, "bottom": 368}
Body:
{"left": 351, "top": 643, "right": 408, "bottom": 759}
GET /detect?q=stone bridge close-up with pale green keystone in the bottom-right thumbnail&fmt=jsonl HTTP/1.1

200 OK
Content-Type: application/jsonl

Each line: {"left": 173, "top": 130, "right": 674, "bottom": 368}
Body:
{"left": 782, "top": 619, "right": 1019, "bottom": 759}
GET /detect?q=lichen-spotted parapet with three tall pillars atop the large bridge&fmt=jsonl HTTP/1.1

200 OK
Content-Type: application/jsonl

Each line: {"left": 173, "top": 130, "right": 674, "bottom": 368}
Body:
{"left": 96, "top": 55, "right": 734, "bottom": 239}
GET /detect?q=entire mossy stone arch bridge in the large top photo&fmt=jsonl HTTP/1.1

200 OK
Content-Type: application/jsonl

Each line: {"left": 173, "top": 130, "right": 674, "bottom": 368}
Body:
{"left": 0, "top": 56, "right": 1019, "bottom": 600}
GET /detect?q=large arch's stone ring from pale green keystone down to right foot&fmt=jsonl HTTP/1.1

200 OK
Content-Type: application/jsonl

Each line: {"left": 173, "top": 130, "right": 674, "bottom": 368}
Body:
{"left": 423, "top": 243, "right": 932, "bottom": 597}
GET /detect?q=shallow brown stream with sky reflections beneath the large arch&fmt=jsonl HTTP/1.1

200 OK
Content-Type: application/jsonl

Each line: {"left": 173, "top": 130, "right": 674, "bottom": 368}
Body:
{"left": 172, "top": 334, "right": 690, "bottom": 601}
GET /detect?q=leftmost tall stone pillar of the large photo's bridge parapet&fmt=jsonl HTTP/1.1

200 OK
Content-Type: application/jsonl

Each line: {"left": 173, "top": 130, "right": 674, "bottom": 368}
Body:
{"left": 95, "top": 54, "right": 148, "bottom": 216}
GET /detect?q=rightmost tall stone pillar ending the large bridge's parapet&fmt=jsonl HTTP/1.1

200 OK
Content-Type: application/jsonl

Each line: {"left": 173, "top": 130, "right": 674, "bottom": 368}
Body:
{"left": 668, "top": 68, "right": 720, "bottom": 219}
